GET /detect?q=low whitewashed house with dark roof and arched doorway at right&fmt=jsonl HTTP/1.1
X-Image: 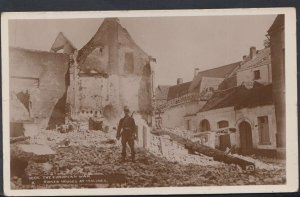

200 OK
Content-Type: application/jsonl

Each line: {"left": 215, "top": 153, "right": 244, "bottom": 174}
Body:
{"left": 194, "top": 84, "right": 277, "bottom": 154}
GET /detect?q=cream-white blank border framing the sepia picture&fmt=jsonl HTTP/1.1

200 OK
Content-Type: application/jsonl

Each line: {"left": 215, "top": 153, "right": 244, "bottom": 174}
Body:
{"left": 1, "top": 8, "right": 298, "bottom": 196}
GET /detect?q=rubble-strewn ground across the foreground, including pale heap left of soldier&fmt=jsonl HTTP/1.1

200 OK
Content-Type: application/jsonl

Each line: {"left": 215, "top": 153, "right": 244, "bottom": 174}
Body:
{"left": 12, "top": 131, "right": 285, "bottom": 188}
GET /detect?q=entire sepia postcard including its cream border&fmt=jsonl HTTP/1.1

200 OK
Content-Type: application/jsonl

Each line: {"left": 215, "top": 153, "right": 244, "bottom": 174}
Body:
{"left": 1, "top": 8, "right": 298, "bottom": 195}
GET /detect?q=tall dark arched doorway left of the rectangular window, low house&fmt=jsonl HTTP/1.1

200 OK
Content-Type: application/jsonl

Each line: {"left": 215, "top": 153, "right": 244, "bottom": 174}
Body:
{"left": 239, "top": 121, "right": 253, "bottom": 155}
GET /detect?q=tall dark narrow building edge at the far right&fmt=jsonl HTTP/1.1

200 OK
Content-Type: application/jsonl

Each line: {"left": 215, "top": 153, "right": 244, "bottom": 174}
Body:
{"left": 268, "top": 15, "right": 286, "bottom": 157}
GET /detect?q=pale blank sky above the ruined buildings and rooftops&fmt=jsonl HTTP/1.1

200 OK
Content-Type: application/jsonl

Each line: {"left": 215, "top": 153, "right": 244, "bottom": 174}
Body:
{"left": 9, "top": 15, "right": 276, "bottom": 85}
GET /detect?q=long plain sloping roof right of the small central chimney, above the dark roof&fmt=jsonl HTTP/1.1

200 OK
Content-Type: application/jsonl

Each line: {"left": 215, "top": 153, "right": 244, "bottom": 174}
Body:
{"left": 189, "top": 62, "right": 240, "bottom": 92}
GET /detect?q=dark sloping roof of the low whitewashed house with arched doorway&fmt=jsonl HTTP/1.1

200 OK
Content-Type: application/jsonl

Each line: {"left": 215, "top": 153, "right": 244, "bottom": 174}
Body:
{"left": 200, "top": 82, "right": 273, "bottom": 112}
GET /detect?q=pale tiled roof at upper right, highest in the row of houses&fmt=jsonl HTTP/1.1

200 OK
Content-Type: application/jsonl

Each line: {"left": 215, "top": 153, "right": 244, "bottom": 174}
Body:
{"left": 239, "top": 48, "right": 271, "bottom": 70}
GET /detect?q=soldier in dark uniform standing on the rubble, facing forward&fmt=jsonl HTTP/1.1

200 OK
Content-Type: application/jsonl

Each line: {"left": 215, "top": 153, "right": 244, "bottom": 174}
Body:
{"left": 116, "top": 106, "right": 136, "bottom": 162}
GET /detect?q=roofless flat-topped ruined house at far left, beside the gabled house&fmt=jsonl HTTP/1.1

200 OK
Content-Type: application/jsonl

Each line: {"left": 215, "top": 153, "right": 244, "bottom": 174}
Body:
{"left": 9, "top": 47, "right": 69, "bottom": 134}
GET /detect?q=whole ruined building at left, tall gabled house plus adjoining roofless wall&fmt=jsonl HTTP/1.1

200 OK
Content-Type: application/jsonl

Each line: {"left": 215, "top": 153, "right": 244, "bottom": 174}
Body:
{"left": 9, "top": 18, "right": 155, "bottom": 138}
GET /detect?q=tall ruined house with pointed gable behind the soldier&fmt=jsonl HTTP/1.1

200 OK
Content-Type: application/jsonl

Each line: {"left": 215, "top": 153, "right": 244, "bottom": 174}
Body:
{"left": 67, "top": 18, "right": 154, "bottom": 123}
